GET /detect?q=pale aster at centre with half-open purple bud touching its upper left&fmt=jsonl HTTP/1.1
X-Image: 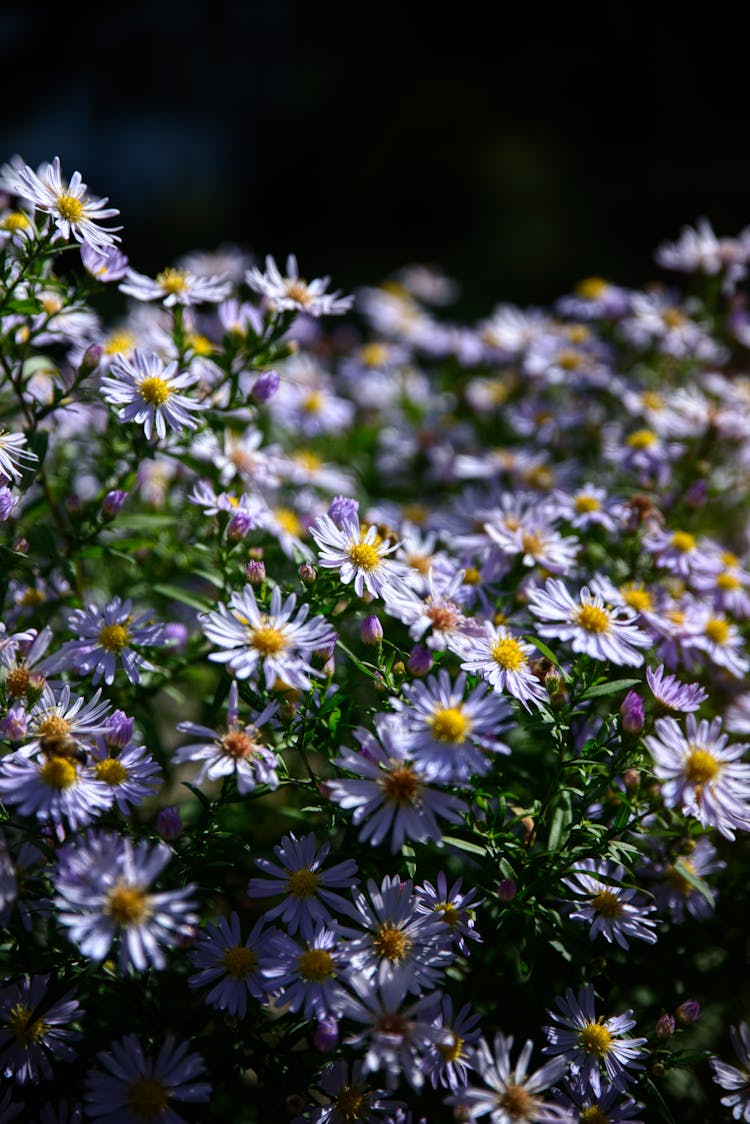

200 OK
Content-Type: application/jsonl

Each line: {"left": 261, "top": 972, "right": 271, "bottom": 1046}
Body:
{"left": 310, "top": 513, "right": 408, "bottom": 597}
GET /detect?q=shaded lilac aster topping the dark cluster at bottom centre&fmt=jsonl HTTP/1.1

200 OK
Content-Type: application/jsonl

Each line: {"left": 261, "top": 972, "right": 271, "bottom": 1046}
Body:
{"left": 247, "top": 832, "right": 356, "bottom": 940}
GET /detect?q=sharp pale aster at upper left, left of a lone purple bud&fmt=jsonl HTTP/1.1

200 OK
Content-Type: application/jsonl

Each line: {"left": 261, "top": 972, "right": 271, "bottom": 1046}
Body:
{"left": 101, "top": 347, "right": 202, "bottom": 441}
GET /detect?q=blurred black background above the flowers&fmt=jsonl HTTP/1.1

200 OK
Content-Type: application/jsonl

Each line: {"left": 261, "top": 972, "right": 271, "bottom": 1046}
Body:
{"left": 0, "top": 0, "right": 750, "bottom": 315}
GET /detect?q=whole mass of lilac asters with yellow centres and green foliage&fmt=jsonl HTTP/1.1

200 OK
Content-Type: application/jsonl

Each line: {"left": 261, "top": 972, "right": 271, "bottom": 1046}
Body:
{"left": 0, "top": 158, "right": 750, "bottom": 1124}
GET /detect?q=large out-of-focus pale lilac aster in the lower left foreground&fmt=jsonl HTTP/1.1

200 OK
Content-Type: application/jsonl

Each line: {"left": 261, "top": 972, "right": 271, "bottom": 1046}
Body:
{"left": 55, "top": 832, "right": 198, "bottom": 972}
